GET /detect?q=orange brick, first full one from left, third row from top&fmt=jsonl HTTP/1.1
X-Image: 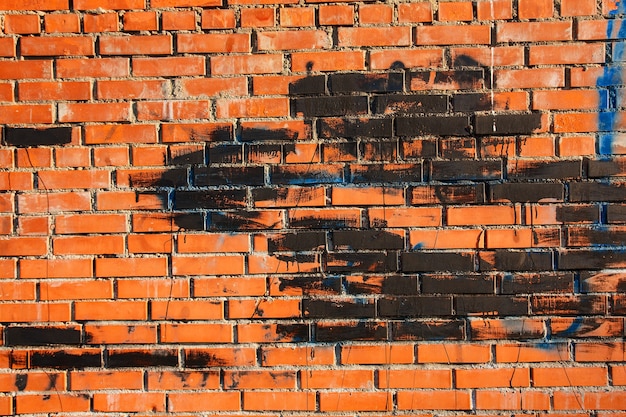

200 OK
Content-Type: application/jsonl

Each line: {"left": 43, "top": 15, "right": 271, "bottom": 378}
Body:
{"left": 20, "top": 36, "right": 94, "bottom": 56}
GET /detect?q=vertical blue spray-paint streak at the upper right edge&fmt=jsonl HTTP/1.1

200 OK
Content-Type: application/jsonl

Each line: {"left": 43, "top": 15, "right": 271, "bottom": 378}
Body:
{"left": 596, "top": 1, "right": 626, "bottom": 155}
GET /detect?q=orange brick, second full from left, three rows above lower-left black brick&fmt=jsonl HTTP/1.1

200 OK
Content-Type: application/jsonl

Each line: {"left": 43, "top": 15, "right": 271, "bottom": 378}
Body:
{"left": 96, "top": 258, "right": 167, "bottom": 277}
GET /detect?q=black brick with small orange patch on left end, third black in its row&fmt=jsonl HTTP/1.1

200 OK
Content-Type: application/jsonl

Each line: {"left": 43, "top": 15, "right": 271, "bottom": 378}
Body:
{"left": 479, "top": 249, "right": 553, "bottom": 271}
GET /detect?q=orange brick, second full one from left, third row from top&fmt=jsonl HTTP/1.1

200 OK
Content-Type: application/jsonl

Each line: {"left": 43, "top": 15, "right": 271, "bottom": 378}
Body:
{"left": 100, "top": 35, "right": 172, "bottom": 55}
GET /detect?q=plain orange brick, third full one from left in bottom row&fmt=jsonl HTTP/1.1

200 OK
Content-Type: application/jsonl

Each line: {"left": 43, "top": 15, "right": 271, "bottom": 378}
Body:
{"left": 167, "top": 391, "right": 241, "bottom": 413}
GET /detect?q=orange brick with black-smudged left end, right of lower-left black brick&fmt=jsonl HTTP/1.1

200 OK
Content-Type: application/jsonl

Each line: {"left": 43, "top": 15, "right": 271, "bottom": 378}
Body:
{"left": 85, "top": 324, "right": 157, "bottom": 342}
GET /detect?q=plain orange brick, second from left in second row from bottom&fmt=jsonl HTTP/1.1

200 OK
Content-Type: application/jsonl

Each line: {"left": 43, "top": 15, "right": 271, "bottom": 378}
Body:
{"left": 69, "top": 371, "right": 143, "bottom": 391}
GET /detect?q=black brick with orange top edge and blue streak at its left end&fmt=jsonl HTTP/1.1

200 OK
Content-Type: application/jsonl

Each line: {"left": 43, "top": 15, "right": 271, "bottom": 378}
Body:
{"left": 350, "top": 163, "right": 422, "bottom": 184}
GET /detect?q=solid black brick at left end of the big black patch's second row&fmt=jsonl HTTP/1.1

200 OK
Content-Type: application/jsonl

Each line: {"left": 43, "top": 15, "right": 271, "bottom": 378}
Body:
{"left": 293, "top": 96, "right": 368, "bottom": 117}
